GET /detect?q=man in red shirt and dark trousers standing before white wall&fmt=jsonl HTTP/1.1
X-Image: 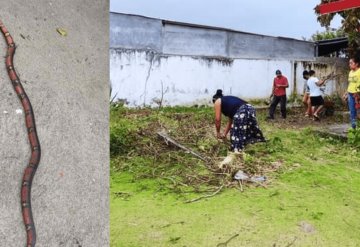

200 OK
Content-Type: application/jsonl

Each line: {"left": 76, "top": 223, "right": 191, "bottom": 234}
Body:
{"left": 267, "top": 70, "right": 289, "bottom": 119}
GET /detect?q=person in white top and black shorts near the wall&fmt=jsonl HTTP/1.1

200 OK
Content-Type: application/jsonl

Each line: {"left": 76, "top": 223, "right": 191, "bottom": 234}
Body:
{"left": 307, "top": 70, "right": 326, "bottom": 121}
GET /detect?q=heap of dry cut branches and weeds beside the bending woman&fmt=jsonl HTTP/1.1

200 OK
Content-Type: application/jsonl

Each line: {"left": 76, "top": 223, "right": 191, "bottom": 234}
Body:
{"left": 112, "top": 109, "right": 277, "bottom": 201}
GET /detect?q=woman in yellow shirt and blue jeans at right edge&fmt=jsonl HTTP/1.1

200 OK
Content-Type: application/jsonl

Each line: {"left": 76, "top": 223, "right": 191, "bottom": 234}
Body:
{"left": 344, "top": 53, "right": 360, "bottom": 129}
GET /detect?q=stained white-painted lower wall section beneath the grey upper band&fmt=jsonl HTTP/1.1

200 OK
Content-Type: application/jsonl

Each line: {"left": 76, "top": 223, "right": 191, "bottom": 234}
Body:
{"left": 110, "top": 49, "right": 296, "bottom": 106}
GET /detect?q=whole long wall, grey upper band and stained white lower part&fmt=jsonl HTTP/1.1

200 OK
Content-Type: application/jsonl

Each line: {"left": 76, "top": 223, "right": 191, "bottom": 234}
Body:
{"left": 110, "top": 13, "right": 343, "bottom": 107}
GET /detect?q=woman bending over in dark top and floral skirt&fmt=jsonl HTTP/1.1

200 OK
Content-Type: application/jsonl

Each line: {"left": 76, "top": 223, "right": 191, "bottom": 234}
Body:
{"left": 213, "top": 89, "right": 265, "bottom": 152}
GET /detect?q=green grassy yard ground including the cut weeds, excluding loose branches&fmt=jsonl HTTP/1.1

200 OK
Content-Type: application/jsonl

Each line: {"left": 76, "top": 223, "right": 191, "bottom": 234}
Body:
{"left": 110, "top": 107, "right": 360, "bottom": 247}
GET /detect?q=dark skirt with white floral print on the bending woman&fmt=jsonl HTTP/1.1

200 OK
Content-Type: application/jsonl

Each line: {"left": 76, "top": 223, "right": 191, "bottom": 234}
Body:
{"left": 230, "top": 104, "right": 265, "bottom": 152}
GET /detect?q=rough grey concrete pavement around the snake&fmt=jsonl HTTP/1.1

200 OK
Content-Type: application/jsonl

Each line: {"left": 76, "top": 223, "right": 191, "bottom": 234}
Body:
{"left": 0, "top": 0, "right": 109, "bottom": 247}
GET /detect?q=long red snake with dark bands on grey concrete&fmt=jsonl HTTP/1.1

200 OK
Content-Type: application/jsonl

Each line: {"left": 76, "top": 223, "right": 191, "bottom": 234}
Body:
{"left": 0, "top": 20, "right": 41, "bottom": 247}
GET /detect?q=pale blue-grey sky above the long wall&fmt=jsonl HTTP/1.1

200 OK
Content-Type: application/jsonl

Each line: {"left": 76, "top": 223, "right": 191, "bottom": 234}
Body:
{"left": 110, "top": 0, "right": 341, "bottom": 40}
